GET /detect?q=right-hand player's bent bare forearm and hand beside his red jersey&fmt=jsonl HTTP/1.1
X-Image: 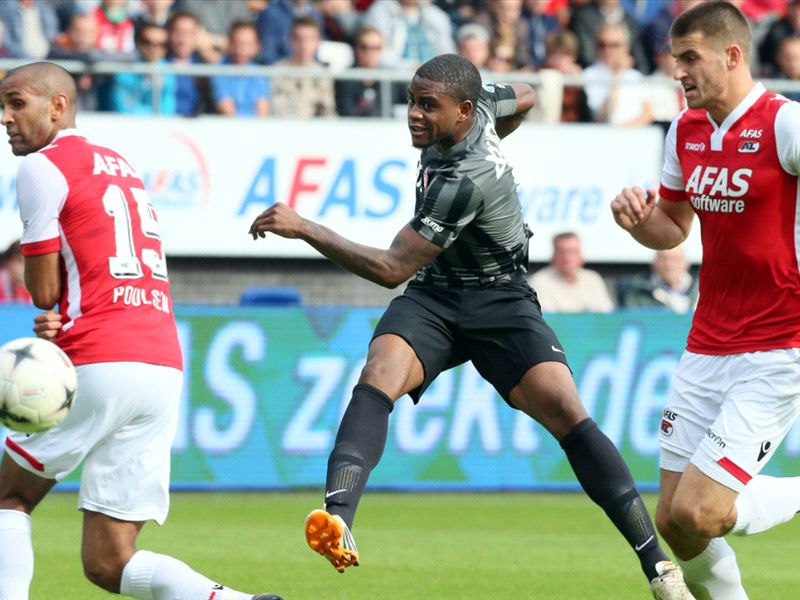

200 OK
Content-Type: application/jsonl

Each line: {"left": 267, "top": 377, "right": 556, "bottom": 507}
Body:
{"left": 611, "top": 187, "right": 694, "bottom": 250}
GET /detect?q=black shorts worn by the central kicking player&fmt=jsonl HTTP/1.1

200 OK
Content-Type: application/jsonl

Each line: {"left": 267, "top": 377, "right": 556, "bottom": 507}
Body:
{"left": 372, "top": 280, "right": 567, "bottom": 403}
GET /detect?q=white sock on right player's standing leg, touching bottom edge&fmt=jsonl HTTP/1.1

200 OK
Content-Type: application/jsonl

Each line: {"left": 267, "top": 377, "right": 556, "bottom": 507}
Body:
{"left": 677, "top": 538, "right": 747, "bottom": 600}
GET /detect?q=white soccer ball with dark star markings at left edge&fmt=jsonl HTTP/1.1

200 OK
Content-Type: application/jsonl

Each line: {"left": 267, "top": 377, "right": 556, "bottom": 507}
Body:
{"left": 0, "top": 338, "right": 78, "bottom": 433}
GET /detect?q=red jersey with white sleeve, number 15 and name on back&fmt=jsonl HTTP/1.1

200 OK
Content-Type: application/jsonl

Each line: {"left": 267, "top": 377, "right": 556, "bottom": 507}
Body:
{"left": 17, "top": 129, "right": 182, "bottom": 369}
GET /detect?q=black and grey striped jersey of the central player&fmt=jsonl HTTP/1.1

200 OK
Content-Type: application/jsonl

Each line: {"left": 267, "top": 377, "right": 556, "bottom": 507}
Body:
{"left": 410, "top": 84, "right": 530, "bottom": 288}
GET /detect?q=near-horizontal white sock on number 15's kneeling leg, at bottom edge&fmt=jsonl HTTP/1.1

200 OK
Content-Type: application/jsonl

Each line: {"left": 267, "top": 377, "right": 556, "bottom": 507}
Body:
{"left": 120, "top": 550, "right": 253, "bottom": 600}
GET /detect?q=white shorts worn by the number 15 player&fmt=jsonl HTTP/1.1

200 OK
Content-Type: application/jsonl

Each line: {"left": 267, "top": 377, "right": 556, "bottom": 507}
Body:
{"left": 6, "top": 362, "right": 183, "bottom": 524}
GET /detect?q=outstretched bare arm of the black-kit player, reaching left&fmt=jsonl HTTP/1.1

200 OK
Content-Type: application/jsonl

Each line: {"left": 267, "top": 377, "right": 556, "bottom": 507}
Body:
{"left": 250, "top": 202, "right": 443, "bottom": 288}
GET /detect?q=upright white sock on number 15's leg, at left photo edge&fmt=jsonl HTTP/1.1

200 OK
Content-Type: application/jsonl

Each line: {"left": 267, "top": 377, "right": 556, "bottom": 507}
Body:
{"left": 0, "top": 510, "right": 33, "bottom": 600}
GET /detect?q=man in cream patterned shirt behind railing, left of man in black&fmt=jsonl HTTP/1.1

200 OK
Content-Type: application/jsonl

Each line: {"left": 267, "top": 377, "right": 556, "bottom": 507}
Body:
{"left": 272, "top": 15, "right": 336, "bottom": 119}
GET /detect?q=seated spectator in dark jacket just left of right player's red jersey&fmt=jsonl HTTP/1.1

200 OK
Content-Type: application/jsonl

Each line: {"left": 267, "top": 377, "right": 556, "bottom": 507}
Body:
{"left": 617, "top": 246, "right": 698, "bottom": 313}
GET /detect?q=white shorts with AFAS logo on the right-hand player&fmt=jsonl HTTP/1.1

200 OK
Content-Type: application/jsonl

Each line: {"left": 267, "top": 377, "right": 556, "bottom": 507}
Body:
{"left": 659, "top": 348, "right": 800, "bottom": 492}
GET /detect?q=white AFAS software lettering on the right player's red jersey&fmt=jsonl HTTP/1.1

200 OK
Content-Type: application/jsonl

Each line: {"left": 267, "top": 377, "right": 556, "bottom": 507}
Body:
{"left": 686, "top": 165, "right": 753, "bottom": 213}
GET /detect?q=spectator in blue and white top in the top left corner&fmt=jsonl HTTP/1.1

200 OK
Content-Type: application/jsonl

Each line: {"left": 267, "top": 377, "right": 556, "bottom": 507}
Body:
{"left": 0, "top": 0, "right": 58, "bottom": 58}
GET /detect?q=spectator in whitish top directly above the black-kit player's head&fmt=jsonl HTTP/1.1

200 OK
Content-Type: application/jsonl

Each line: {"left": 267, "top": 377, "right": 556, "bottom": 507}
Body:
{"left": 364, "top": 0, "right": 455, "bottom": 68}
